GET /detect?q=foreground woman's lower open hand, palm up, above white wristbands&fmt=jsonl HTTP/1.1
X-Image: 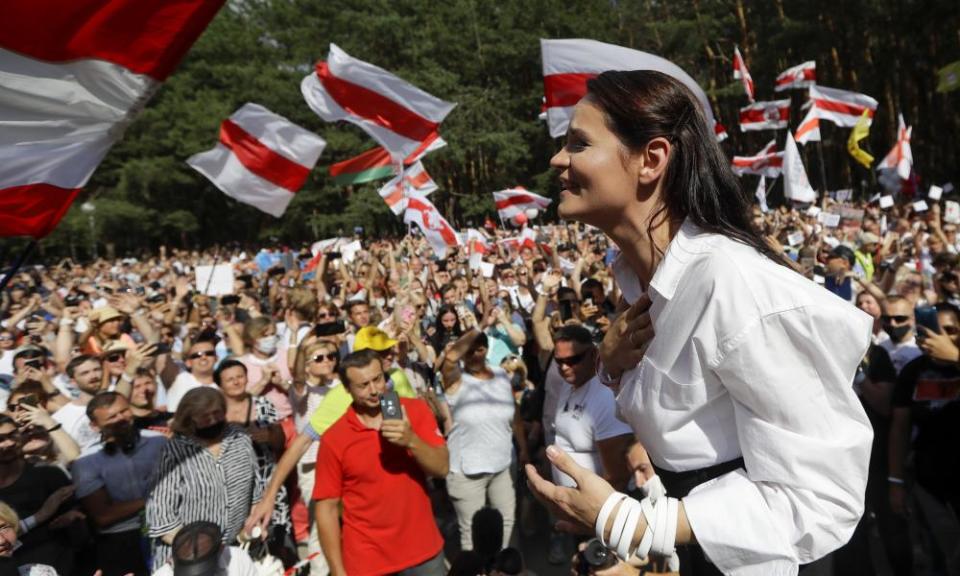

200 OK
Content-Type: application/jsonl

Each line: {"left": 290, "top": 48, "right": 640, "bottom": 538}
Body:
{"left": 526, "top": 446, "right": 614, "bottom": 534}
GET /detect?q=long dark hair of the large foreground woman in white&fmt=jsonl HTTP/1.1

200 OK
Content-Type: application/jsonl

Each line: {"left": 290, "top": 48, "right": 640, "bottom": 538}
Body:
{"left": 587, "top": 70, "right": 790, "bottom": 267}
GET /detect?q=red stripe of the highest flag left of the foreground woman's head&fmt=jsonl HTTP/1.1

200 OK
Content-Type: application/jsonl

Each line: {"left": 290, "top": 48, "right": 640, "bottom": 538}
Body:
{"left": 317, "top": 62, "right": 440, "bottom": 142}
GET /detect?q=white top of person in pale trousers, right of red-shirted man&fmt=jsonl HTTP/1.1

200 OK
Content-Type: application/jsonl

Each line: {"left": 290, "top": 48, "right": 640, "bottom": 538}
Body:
{"left": 447, "top": 367, "right": 515, "bottom": 474}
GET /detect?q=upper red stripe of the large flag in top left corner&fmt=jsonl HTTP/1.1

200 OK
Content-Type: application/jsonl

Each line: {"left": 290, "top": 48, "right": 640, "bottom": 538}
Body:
{"left": 0, "top": 0, "right": 224, "bottom": 81}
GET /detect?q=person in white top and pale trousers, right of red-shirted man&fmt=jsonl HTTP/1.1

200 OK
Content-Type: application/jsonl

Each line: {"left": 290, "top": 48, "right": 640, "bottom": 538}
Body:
{"left": 441, "top": 321, "right": 526, "bottom": 550}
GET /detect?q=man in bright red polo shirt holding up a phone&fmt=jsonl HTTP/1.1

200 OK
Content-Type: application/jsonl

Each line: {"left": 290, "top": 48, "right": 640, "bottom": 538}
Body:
{"left": 313, "top": 350, "right": 449, "bottom": 576}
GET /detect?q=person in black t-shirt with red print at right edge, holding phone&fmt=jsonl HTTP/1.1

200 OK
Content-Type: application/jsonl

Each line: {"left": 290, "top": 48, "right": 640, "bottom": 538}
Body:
{"left": 888, "top": 304, "right": 960, "bottom": 513}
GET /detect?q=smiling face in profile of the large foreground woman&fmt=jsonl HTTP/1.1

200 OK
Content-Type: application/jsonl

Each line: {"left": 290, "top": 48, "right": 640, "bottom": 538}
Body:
{"left": 550, "top": 98, "right": 639, "bottom": 229}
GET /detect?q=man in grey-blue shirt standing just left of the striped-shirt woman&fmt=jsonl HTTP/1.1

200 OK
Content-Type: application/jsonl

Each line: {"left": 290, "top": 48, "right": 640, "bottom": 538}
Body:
{"left": 71, "top": 392, "right": 166, "bottom": 576}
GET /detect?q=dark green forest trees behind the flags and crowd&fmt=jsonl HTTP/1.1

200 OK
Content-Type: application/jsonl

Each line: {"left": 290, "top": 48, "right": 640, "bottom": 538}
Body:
{"left": 11, "top": 0, "right": 960, "bottom": 258}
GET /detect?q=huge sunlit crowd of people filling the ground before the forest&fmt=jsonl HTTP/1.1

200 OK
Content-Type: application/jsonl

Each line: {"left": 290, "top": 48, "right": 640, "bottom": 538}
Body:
{"left": 0, "top": 191, "right": 960, "bottom": 576}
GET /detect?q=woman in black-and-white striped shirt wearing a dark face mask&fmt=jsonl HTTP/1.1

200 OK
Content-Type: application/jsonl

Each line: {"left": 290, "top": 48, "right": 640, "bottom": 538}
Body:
{"left": 146, "top": 388, "right": 262, "bottom": 568}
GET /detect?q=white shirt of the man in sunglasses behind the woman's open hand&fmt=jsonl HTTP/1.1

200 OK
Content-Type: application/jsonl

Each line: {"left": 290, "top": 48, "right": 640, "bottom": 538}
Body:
{"left": 553, "top": 376, "right": 633, "bottom": 488}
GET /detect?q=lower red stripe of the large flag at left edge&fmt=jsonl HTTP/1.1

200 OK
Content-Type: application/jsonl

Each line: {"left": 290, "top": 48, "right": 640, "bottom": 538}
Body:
{"left": 0, "top": 183, "right": 80, "bottom": 238}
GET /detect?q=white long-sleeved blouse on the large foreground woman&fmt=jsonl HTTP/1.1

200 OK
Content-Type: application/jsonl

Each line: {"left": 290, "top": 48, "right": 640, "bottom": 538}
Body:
{"left": 614, "top": 220, "right": 873, "bottom": 576}
